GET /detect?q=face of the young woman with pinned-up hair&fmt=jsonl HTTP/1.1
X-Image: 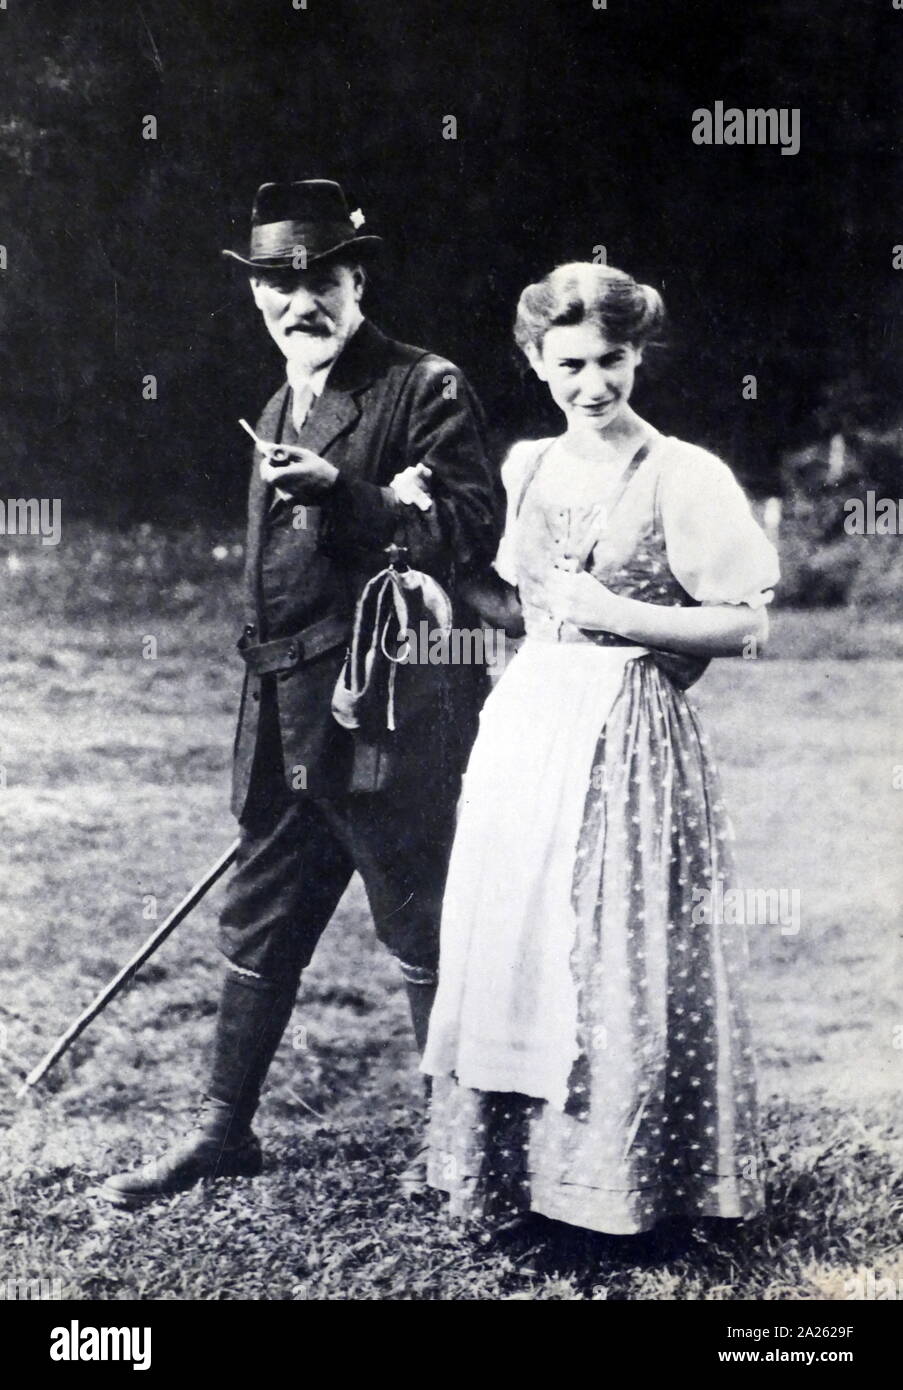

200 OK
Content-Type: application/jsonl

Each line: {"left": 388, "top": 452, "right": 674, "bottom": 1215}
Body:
{"left": 528, "top": 321, "right": 643, "bottom": 434}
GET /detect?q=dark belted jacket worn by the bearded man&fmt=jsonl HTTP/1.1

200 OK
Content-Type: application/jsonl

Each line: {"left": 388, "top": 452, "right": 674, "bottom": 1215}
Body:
{"left": 232, "top": 321, "right": 503, "bottom": 817}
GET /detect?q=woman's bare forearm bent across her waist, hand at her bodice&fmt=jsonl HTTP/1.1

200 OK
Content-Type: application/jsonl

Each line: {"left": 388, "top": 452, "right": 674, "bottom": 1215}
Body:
{"left": 545, "top": 570, "right": 768, "bottom": 656}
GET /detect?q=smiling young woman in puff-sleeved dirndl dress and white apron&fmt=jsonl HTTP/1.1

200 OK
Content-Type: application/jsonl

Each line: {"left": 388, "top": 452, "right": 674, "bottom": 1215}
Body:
{"left": 424, "top": 264, "right": 778, "bottom": 1234}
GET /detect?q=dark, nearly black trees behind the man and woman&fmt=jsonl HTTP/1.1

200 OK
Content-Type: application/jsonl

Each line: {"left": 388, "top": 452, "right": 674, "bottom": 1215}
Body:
{"left": 0, "top": 0, "right": 903, "bottom": 521}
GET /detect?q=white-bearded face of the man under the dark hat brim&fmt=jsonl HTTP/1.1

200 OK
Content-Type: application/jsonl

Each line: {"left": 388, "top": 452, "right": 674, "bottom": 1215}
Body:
{"left": 251, "top": 261, "right": 364, "bottom": 371}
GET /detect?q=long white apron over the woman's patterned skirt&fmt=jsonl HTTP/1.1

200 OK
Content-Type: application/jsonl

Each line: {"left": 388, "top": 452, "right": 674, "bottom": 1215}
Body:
{"left": 422, "top": 637, "right": 646, "bottom": 1109}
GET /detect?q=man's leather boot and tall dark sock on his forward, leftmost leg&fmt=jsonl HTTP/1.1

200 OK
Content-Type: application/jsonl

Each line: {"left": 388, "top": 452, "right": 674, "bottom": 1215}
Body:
{"left": 100, "top": 970, "right": 297, "bottom": 1209}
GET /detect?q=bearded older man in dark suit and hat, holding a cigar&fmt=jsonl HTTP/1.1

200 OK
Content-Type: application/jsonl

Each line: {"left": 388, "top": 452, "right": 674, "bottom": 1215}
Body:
{"left": 101, "top": 179, "right": 500, "bottom": 1208}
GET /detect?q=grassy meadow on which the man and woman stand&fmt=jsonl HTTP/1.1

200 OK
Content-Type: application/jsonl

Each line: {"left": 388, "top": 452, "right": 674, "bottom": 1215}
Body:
{"left": 0, "top": 531, "right": 903, "bottom": 1300}
